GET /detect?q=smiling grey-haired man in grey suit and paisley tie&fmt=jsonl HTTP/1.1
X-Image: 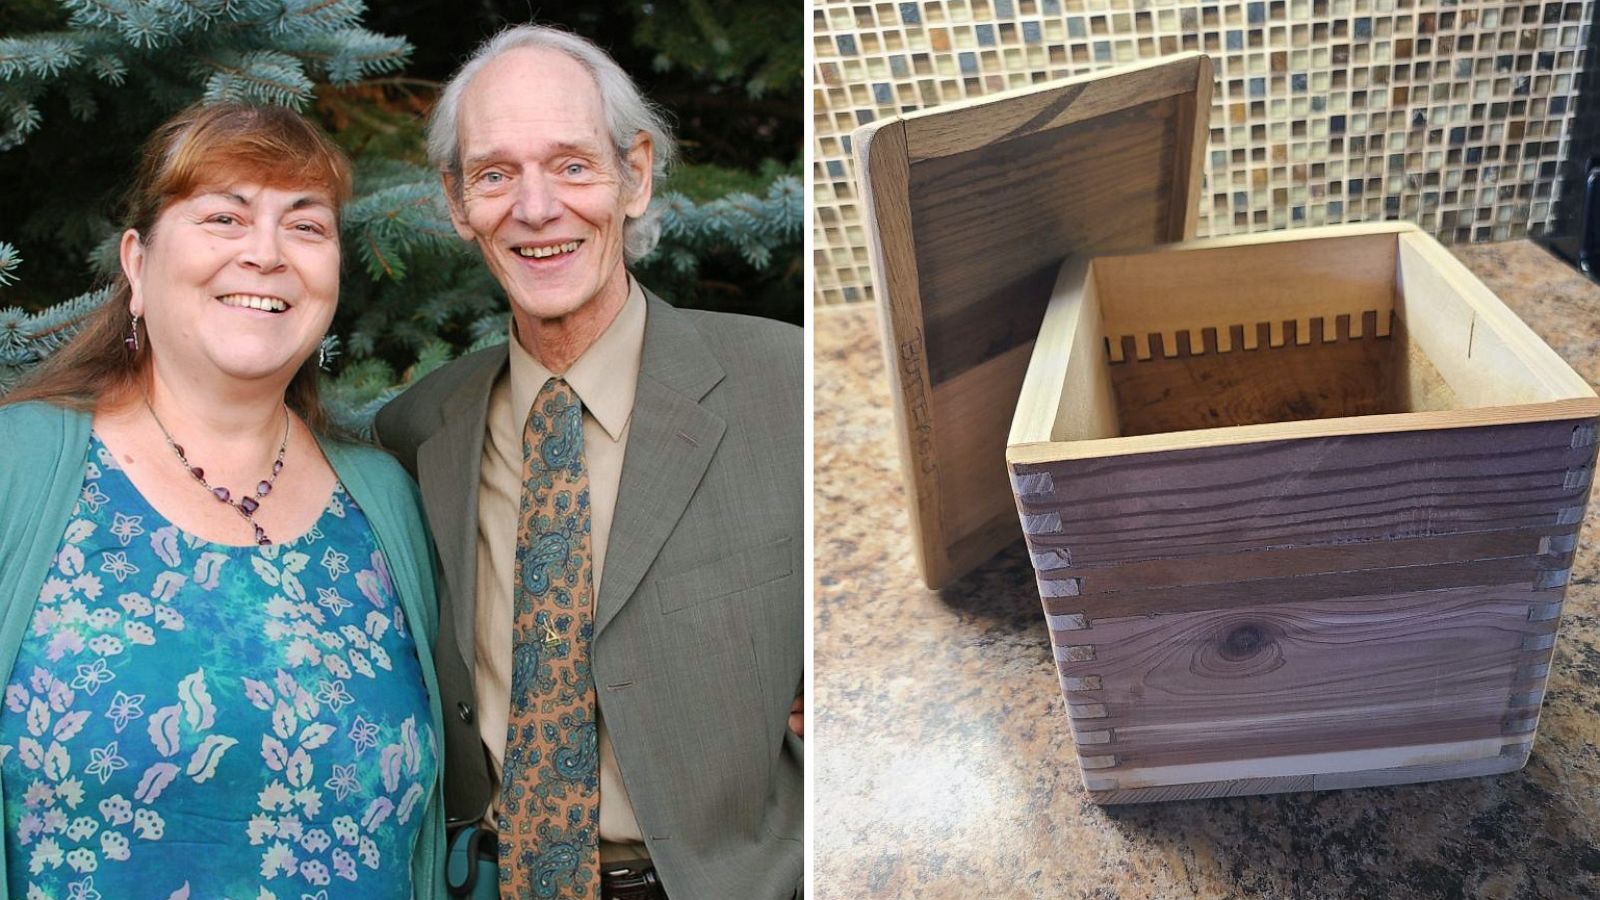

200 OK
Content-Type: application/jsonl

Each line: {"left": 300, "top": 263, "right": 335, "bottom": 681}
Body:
{"left": 378, "top": 26, "right": 803, "bottom": 900}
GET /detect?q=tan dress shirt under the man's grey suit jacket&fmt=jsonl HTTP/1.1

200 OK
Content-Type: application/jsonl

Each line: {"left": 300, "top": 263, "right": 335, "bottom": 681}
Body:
{"left": 475, "top": 279, "right": 650, "bottom": 862}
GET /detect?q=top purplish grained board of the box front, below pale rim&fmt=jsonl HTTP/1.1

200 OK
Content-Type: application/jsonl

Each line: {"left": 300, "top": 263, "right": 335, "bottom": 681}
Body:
{"left": 1014, "top": 421, "right": 1595, "bottom": 565}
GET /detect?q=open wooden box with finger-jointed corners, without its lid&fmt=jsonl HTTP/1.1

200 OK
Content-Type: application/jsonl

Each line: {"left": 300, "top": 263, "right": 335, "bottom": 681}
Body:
{"left": 1008, "top": 226, "right": 1600, "bottom": 802}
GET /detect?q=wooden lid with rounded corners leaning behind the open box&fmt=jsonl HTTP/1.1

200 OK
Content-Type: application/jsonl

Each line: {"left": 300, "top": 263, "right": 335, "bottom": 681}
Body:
{"left": 854, "top": 53, "right": 1213, "bottom": 588}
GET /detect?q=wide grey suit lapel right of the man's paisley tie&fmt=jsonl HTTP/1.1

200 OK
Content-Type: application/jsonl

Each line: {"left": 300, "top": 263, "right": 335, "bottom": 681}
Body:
{"left": 595, "top": 291, "right": 726, "bottom": 637}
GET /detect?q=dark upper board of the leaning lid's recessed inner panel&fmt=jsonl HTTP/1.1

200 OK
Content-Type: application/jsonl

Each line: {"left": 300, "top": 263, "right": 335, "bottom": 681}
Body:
{"left": 909, "top": 98, "right": 1192, "bottom": 385}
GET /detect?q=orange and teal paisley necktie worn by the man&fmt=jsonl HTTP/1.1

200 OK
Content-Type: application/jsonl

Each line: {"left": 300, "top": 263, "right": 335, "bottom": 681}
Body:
{"left": 498, "top": 378, "right": 600, "bottom": 900}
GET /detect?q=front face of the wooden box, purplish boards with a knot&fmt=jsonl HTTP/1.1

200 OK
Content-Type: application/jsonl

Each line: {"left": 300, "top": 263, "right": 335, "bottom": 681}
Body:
{"left": 1030, "top": 406, "right": 1597, "bottom": 802}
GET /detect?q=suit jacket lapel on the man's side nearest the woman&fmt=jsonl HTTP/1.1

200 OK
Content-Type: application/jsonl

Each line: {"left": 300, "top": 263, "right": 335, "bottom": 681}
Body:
{"left": 416, "top": 342, "right": 507, "bottom": 671}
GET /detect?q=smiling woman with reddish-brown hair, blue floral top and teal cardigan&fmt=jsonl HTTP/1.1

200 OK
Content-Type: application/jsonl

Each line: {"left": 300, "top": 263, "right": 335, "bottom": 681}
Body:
{"left": 0, "top": 106, "right": 443, "bottom": 897}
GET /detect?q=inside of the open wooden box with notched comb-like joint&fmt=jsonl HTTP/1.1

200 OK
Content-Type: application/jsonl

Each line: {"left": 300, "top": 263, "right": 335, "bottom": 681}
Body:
{"left": 1011, "top": 229, "right": 1594, "bottom": 444}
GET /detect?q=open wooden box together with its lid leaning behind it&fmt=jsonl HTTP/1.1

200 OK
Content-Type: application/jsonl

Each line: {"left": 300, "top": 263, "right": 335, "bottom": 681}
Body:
{"left": 856, "top": 54, "right": 1600, "bottom": 802}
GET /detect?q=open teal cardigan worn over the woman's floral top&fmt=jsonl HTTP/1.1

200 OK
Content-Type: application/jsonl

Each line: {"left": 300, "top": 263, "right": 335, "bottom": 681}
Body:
{"left": 0, "top": 404, "right": 445, "bottom": 900}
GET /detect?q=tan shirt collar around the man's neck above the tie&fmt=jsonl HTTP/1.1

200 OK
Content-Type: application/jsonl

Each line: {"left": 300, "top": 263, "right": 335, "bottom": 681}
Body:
{"left": 510, "top": 275, "right": 645, "bottom": 440}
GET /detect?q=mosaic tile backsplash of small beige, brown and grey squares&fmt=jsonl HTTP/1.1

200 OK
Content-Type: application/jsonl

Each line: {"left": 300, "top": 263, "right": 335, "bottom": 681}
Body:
{"left": 813, "top": 0, "right": 1595, "bottom": 304}
